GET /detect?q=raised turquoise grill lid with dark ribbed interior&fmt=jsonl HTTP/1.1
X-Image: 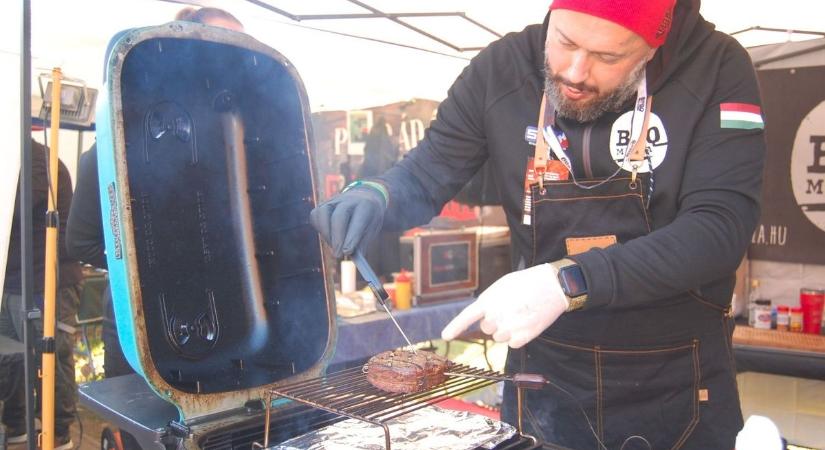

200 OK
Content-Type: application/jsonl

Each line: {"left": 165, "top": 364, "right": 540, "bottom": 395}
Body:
{"left": 97, "top": 22, "right": 336, "bottom": 420}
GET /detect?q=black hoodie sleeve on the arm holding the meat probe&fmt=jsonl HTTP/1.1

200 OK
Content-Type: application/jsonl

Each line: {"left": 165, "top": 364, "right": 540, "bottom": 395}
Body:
{"left": 379, "top": 49, "right": 490, "bottom": 230}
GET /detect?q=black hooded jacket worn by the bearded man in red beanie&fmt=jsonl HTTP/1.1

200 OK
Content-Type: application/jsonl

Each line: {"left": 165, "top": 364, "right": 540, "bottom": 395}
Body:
{"left": 380, "top": 0, "right": 765, "bottom": 316}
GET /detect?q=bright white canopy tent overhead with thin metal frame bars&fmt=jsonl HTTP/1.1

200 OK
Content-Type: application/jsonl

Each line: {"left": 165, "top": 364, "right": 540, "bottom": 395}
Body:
{"left": 0, "top": 0, "right": 825, "bottom": 294}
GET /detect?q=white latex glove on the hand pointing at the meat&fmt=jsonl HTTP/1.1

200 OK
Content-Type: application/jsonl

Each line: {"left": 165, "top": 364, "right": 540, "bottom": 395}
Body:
{"left": 441, "top": 264, "right": 567, "bottom": 348}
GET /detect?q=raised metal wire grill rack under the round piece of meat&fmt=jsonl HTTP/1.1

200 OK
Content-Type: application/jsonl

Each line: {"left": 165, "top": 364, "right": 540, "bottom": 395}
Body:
{"left": 264, "top": 364, "right": 521, "bottom": 450}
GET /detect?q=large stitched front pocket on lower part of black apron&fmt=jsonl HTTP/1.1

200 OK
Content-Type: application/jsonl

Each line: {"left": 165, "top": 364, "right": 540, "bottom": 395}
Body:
{"left": 504, "top": 336, "right": 701, "bottom": 449}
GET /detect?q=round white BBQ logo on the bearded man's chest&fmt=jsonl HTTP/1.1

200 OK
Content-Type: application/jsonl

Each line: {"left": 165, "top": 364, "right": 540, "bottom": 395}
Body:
{"left": 610, "top": 111, "right": 667, "bottom": 173}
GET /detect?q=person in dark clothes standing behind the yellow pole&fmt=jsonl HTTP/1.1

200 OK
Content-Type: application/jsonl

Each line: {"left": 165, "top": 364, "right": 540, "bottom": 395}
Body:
{"left": 0, "top": 139, "right": 83, "bottom": 450}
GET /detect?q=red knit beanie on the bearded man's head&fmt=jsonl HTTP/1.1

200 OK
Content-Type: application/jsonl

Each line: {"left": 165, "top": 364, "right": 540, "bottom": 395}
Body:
{"left": 550, "top": 0, "right": 676, "bottom": 48}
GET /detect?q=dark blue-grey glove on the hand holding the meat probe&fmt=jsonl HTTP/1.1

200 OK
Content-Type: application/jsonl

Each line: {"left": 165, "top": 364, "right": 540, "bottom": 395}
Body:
{"left": 309, "top": 185, "right": 387, "bottom": 258}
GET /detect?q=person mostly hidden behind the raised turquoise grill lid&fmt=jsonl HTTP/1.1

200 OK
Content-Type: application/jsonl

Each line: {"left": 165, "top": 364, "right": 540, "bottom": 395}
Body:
{"left": 66, "top": 8, "right": 244, "bottom": 377}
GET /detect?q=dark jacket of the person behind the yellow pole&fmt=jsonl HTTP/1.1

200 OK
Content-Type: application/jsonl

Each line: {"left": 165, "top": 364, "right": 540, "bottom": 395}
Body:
{"left": 3, "top": 140, "right": 83, "bottom": 295}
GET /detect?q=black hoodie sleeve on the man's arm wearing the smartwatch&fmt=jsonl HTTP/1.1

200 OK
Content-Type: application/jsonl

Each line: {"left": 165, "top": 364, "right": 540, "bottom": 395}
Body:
{"left": 573, "top": 38, "right": 766, "bottom": 308}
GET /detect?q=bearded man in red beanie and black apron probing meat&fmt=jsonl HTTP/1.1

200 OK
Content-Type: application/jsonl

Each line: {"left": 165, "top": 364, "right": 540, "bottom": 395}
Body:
{"left": 310, "top": 0, "right": 765, "bottom": 450}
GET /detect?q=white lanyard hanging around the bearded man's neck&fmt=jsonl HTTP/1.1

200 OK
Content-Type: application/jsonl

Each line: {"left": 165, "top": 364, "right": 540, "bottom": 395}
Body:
{"left": 533, "top": 75, "right": 653, "bottom": 188}
